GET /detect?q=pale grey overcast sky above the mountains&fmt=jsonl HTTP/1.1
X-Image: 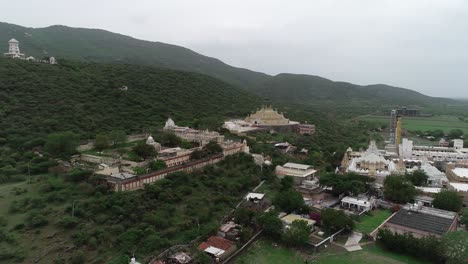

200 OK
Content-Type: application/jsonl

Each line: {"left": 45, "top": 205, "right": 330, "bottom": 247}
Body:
{"left": 0, "top": 0, "right": 468, "bottom": 98}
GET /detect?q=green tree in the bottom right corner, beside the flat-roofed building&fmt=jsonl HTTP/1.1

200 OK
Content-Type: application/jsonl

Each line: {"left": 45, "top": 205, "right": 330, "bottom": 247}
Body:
{"left": 442, "top": 231, "right": 468, "bottom": 264}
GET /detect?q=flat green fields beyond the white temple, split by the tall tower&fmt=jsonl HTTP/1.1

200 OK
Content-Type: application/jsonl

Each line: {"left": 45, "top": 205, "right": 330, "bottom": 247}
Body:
{"left": 359, "top": 115, "right": 468, "bottom": 134}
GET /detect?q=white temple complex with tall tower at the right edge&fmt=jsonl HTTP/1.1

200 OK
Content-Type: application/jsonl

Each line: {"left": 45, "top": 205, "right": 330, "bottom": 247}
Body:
{"left": 340, "top": 106, "right": 468, "bottom": 205}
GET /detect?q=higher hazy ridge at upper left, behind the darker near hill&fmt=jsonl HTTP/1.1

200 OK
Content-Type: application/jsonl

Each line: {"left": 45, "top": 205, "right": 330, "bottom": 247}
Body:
{"left": 0, "top": 22, "right": 269, "bottom": 91}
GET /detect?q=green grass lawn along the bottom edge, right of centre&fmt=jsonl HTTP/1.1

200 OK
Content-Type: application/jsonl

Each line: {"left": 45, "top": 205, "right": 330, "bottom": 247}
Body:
{"left": 234, "top": 240, "right": 426, "bottom": 264}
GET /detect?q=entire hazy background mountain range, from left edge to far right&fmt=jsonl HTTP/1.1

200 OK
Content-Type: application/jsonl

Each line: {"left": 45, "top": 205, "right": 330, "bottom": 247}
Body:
{"left": 0, "top": 23, "right": 460, "bottom": 108}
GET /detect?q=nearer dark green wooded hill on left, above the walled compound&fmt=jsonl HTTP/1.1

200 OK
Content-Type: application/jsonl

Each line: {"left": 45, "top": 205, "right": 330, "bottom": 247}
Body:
{"left": 0, "top": 58, "right": 260, "bottom": 142}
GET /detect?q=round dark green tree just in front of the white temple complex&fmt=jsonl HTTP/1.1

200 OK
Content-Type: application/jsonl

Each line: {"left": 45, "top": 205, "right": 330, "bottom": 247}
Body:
{"left": 384, "top": 175, "right": 417, "bottom": 203}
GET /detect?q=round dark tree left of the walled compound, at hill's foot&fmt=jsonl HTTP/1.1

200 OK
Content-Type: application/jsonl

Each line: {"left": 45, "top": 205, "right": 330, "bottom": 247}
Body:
{"left": 45, "top": 131, "right": 79, "bottom": 158}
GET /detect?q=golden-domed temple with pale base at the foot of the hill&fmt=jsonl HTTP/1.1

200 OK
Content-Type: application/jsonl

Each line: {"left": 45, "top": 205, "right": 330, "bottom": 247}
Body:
{"left": 223, "top": 106, "right": 315, "bottom": 135}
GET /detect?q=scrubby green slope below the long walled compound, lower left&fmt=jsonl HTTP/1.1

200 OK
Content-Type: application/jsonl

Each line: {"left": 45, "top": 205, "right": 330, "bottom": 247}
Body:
{"left": 0, "top": 154, "right": 262, "bottom": 264}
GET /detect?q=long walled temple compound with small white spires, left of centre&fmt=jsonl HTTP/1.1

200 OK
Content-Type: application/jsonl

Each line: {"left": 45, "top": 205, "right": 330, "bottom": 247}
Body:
{"left": 77, "top": 118, "right": 250, "bottom": 192}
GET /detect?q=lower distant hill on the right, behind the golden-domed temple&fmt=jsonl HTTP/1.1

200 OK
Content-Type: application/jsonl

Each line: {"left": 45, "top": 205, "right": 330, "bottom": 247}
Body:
{"left": 255, "top": 73, "right": 453, "bottom": 107}
